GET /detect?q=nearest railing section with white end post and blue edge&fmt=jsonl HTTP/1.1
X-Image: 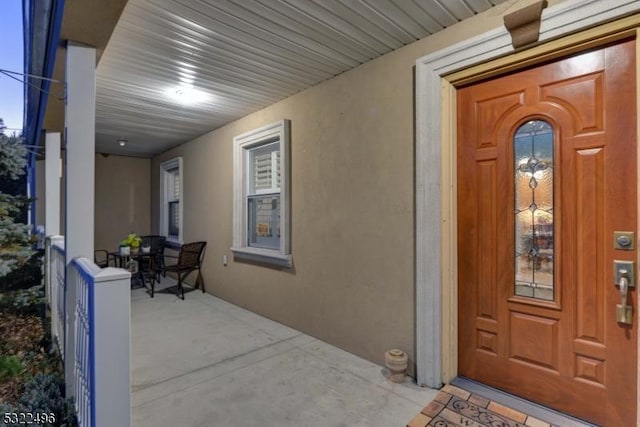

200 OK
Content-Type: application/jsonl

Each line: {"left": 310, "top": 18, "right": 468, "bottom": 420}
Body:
{"left": 65, "top": 258, "right": 131, "bottom": 427}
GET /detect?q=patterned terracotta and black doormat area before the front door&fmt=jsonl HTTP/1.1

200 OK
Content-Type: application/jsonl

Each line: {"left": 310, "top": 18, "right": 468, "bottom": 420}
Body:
{"left": 407, "top": 384, "right": 551, "bottom": 427}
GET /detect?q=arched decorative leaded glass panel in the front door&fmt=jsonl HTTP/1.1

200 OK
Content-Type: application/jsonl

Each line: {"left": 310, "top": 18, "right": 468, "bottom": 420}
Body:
{"left": 513, "top": 120, "right": 553, "bottom": 301}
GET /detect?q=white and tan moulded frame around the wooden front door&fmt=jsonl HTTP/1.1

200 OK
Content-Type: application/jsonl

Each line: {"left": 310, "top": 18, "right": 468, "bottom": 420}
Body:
{"left": 415, "top": 0, "right": 640, "bottom": 398}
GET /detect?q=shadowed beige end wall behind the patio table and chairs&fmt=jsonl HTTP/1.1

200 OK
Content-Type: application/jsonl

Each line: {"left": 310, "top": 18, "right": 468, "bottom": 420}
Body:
{"left": 94, "top": 154, "right": 151, "bottom": 250}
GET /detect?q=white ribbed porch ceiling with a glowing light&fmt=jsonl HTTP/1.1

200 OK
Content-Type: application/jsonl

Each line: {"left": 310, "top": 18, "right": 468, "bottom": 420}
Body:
{"left": 96, "top": 0, "right": 506, "bottom": 157}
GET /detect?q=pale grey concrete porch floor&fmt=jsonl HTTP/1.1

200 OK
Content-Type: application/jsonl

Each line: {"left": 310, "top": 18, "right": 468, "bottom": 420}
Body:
{"left": 131, "top": 280, "right": 437, "bottom": 427}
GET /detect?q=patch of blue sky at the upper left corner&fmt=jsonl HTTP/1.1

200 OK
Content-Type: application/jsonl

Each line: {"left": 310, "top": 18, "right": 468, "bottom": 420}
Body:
{"left": 0, "top": 0, "right": 24, "bottom": 133}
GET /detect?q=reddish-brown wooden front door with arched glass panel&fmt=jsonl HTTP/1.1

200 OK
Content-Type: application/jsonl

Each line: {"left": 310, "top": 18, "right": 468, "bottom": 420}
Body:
{"left": 457, "top": 40, "right": 638, "bottom": 426}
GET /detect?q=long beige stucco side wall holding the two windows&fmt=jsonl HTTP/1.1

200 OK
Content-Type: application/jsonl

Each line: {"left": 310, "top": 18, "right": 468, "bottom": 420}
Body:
{"left": 151, "top": 1, "right": 557, "bottom": 374}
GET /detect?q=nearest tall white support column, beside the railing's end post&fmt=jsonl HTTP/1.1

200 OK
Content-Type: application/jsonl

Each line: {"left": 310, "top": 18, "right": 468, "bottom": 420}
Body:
{"left": 65, "top": 42, "right": 96, "bottom": 397}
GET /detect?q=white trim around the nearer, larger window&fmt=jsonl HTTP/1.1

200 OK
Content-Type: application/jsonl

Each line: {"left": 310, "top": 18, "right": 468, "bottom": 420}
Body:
{"left": 231, "top": 119, "right": 293, "bottom": 268}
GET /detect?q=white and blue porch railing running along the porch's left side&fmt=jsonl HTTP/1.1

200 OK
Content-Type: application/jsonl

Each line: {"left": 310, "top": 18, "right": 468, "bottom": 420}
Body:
{"left": 46, "top": 236, "right": 131, "bottom": 427}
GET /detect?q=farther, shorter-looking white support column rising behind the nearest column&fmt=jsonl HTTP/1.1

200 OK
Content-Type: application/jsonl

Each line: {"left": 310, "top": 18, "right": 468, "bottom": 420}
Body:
{"left": 44, "top": 132, "right": 62, "bottom": 236}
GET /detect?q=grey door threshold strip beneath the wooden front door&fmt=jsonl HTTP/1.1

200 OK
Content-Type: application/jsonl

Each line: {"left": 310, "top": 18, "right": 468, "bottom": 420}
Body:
{"left": 450, "top": 377, "right": 597, "bottom": 427}
